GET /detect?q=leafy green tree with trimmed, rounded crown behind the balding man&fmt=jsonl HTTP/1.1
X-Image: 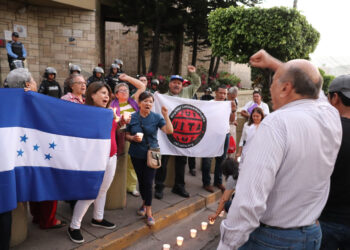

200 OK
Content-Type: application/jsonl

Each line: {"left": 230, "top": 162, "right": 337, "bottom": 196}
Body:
{"left": 209, "top": 7, "right": 320, "bottom": 101}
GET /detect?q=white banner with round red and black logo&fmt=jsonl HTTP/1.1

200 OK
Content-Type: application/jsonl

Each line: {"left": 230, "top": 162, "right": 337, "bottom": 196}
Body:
{"left": 153, "top": 93, "right": 231, "bottom": 157}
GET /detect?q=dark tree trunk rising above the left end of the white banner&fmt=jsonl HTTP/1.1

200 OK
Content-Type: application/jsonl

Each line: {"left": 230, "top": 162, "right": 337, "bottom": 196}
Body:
{"left": 148, "top": 3, "right": 161, "bottom": 75}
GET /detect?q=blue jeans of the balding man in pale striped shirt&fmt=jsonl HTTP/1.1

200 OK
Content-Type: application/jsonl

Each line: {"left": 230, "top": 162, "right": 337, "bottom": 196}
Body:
{"left": 239, "top": 224, "right": 322, "bottom": 250}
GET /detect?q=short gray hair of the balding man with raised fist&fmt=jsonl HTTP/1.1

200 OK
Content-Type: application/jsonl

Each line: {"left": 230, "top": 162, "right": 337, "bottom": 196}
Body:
{"left": 280, "top": 66, "right": 323, "bottom": 99}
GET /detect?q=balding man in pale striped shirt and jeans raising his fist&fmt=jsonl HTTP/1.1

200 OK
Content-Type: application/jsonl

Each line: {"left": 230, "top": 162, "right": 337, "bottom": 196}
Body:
{"left": 218, "top": 50, "right": 342, "bottom": 250}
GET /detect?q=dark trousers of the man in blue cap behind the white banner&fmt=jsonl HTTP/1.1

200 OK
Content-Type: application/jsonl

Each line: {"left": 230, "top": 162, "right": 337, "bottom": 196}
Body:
{"left": 154, "top": 155, "right": 187, "bottom": 191}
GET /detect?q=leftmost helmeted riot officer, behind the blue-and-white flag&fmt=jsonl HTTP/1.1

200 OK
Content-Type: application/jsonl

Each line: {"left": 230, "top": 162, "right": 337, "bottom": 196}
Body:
{"left": 38, "top": 67, "right": 62, "bottom": 98}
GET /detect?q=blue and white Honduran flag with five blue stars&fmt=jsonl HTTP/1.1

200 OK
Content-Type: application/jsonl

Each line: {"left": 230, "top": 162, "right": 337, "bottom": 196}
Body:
{"left": 0, "top": 89, "right": 113, "bottom": 213}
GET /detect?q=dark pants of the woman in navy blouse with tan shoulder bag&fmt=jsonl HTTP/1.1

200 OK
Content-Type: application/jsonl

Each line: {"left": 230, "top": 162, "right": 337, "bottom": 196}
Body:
{"left": 131, "top": 157, "right": 156, "bottom": 206}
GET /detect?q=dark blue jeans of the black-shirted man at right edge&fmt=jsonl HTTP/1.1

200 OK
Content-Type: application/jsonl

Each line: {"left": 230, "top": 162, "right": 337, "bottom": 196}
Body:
{"left": 320, "top": 221, "right": 350, "bottom": 250}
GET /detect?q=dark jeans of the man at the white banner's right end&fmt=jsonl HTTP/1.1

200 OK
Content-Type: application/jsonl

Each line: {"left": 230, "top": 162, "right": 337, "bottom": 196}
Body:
{"left": 202, "top": 134, "right": 230, "bottom": 186}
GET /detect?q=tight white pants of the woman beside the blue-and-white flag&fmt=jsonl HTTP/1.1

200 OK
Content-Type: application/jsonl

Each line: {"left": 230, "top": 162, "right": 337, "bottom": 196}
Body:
{"left": 70, "top": 155, "right": 117, "bottom": 229}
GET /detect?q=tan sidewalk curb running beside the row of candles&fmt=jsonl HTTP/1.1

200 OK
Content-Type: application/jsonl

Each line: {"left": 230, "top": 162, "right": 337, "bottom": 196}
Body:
{"left": 76, "top": 190, "right": 221, "bottom": 250}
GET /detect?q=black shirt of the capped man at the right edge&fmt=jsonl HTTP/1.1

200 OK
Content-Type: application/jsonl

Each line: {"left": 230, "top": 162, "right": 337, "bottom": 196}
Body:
{"left": 320, "top": 117, "right": 350, "bottom": 226}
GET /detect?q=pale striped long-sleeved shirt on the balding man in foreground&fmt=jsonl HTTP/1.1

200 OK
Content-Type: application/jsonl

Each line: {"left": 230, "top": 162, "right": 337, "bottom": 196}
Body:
{"left": 218, "top": 96, "right": 342, "bottom": 250}
